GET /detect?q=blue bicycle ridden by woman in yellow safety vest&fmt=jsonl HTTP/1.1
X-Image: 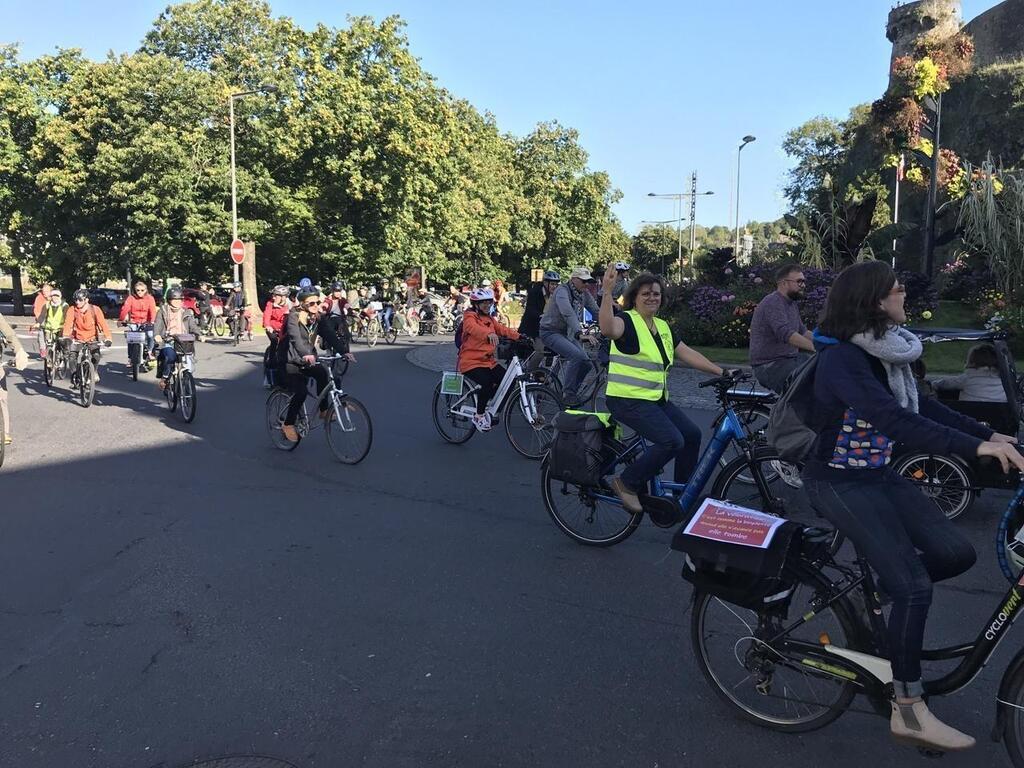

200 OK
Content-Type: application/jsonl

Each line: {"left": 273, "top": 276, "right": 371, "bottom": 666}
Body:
{"left": 541, "top": 372, "right": 783, "bottom": 547}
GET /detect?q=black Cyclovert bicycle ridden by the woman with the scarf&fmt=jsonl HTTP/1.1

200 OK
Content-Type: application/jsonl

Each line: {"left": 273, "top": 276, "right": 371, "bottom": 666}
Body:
{"left": 690, "top": 528, "right": 1024, "bottom": 768}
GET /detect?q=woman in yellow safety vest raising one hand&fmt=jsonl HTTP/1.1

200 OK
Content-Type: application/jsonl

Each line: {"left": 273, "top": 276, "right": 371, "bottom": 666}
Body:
{"left": 598, "top": 264, "right": 725, "bottom": 512}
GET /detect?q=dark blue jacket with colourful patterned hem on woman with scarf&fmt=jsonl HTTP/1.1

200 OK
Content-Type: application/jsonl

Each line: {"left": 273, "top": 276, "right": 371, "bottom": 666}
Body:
{"left": 804, "top": 332, "right": 992, "bottom": 482}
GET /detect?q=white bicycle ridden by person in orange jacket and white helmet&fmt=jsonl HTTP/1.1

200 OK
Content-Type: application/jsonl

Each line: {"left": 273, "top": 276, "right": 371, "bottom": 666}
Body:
{"left": 433, "top": 342, "right": 562, "bottom": 460}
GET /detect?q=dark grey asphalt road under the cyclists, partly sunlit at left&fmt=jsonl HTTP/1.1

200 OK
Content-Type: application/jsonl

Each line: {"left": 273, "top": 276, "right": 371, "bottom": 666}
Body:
{"left": 0, "top": 335, "right": 1020, "bottom": 768}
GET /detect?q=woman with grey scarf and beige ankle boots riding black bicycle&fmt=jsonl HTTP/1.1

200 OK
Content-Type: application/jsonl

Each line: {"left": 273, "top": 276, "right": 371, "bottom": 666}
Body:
{"left": 803, "top": 261, "right": 1024, "bottom": 752}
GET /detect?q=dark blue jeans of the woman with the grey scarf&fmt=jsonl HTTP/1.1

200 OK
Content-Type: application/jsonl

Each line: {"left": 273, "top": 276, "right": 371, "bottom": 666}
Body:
{"left": 804, "top": 469, "right": 976, "bottom": 696}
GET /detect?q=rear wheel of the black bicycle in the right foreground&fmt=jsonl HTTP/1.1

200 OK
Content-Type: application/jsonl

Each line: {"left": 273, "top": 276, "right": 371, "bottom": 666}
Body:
{"left": 690, "top": 570, "right": 860, "bottom": 733}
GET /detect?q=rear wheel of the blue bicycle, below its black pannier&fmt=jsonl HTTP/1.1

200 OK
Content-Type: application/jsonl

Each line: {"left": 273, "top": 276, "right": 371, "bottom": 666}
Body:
{"left": 541, "top": 441, "right": 643, "bottom": 547}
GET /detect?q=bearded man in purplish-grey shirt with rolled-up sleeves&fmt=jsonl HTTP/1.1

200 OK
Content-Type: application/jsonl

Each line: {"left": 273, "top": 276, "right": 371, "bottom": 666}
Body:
{"left": 751, "top": 264, "right": 814, "bottom": 393}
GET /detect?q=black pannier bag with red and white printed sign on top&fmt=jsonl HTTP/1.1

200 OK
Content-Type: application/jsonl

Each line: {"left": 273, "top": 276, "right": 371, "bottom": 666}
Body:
{"left": 672, "top": 499, "right": 804, "bottom": 609}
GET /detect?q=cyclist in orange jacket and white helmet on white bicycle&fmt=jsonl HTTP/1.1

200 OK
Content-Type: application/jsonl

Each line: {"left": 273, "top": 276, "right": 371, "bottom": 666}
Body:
{"left": 459, "top": 288, "right": 525, "bottom": 432}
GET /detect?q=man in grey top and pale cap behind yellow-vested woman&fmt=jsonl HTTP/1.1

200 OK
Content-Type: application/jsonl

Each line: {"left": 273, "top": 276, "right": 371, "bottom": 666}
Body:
{"left": 541, "top": 266, "right": 600, "bottom": 404}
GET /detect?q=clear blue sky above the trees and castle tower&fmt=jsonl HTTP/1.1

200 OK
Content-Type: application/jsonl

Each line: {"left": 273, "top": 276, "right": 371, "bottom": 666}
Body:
{"left": 0, "top": 0, "right": 997, "bottom": 232}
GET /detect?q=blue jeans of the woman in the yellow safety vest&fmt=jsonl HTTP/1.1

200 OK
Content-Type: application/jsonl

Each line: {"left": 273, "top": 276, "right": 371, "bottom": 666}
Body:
{"left": 605, "top": 397, "right": 700, "bottom": 493}
